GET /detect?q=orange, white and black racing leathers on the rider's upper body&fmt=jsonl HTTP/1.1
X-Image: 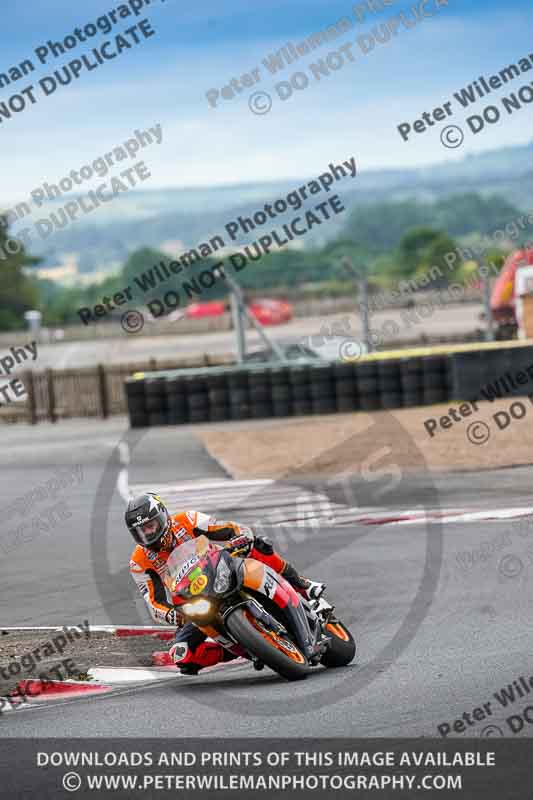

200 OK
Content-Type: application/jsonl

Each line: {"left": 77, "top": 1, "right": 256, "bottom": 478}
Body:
{"left": 130, "top": 511, "right": 286, "bottom": 622}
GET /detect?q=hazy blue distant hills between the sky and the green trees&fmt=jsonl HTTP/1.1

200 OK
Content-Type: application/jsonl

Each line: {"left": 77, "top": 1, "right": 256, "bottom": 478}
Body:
{"left": 13, "top": 142, "right": 533, "bottom": 274}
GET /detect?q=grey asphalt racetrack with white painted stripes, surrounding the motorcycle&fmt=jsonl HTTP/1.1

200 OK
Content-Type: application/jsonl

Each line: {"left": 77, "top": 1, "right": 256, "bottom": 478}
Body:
{"left": 0, "top": 420, "right": 533, "bottom": 738}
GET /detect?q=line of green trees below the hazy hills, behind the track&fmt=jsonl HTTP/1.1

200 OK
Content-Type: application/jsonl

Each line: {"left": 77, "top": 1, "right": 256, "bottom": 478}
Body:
{"left": 0, "top": 193, "right": 520, "bottom": 330}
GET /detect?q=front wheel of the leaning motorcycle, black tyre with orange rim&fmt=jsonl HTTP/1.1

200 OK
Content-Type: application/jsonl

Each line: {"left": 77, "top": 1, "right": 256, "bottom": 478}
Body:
{"left": 226, "top": 607, "right": 309, "bottom": 681}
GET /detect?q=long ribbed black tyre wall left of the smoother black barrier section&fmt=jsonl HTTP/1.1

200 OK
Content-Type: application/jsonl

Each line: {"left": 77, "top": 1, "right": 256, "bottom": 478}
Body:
{"left": 125, "top": 354, "right": 452, "bottom": 428}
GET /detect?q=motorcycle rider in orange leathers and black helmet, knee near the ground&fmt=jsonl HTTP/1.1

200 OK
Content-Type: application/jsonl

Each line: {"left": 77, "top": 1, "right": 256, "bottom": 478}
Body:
{"left": 125, "top": 492, "right": 325, "bottom": 675}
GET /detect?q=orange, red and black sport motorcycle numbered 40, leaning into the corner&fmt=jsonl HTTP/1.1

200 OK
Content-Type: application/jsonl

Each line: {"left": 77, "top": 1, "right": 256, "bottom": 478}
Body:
{"left": 164, "top": 536, "right": 356, "bottom": 681}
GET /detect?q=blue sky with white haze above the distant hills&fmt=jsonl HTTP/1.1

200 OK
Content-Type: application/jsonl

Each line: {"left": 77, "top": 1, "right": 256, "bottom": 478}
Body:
{"left": 0, "top": 0, "right": 533, "bottom": 200}
